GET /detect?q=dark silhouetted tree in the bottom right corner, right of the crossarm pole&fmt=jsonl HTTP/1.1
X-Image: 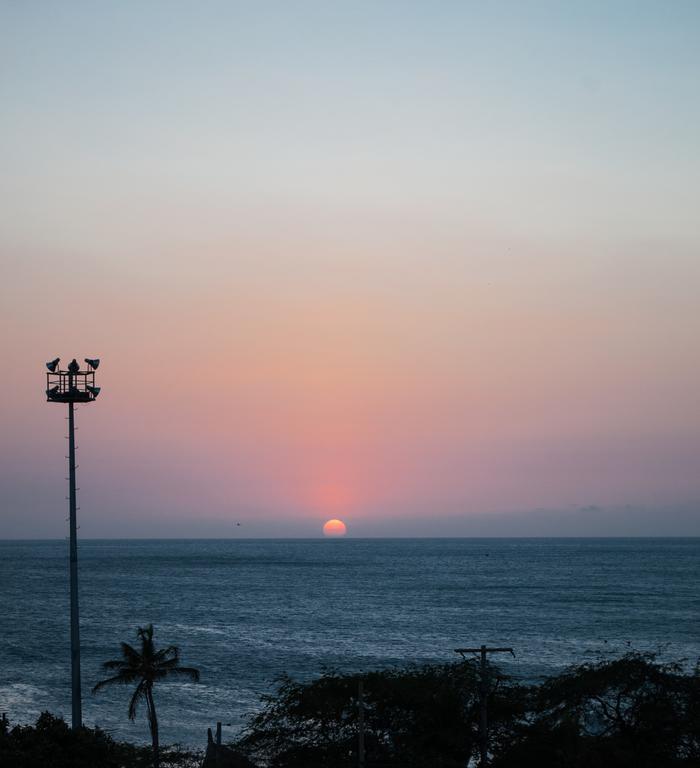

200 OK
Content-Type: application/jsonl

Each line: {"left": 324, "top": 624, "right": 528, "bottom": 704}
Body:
{"left": 493, "top": 654, "right": 700, "bottom": 768}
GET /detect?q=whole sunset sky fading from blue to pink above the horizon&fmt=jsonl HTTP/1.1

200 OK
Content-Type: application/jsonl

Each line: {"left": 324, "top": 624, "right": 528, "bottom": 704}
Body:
{"left": 0, "top": 0, "right": 700, "bottom": 538}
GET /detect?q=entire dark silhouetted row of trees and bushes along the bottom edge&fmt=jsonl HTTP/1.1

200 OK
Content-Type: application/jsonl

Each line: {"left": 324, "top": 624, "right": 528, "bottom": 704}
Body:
{"left": 0, "top": 654, "right": 700, "bottom": 768}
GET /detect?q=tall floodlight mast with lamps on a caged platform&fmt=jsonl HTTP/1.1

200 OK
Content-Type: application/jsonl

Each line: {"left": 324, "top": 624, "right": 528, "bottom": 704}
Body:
{"left": 46, "top": 357, "right": 100, "bottom": 730}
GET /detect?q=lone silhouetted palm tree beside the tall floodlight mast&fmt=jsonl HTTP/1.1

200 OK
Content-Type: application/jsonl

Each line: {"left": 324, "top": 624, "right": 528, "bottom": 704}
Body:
{"left": 92, "top": 624, "right": 199, "bottom": 768}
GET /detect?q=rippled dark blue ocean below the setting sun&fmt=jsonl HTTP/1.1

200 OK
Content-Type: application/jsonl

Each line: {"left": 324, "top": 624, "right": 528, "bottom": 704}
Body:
{"left": 0, "top": 539, "right": 700, "bottom": 747}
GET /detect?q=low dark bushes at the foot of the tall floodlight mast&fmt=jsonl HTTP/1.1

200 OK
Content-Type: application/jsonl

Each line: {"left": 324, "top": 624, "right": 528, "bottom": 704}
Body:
{"left": 0, "top": 712, "right": 201, "bottom": 768}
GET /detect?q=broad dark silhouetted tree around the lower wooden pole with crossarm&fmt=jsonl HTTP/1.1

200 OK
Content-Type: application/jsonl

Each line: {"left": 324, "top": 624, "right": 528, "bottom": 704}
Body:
{"left": 237, "top": 664, "right": 517, "bottom": 768}
